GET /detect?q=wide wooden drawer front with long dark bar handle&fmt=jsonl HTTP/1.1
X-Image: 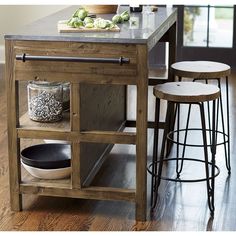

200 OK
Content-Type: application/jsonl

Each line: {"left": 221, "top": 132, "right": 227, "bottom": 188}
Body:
{"left": 14, "top": 41, "right": 137, "bottom": 83}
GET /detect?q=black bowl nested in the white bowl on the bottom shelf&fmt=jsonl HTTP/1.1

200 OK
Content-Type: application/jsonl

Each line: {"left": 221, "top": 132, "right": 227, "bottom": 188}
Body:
{"left": 21, "top": 143, "right": 71, "bottom": 169}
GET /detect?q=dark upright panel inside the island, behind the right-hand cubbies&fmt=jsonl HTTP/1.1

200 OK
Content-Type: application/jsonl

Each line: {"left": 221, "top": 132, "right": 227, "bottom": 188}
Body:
{"left": 80, "top": 84, "right": 126, "bottom": 183}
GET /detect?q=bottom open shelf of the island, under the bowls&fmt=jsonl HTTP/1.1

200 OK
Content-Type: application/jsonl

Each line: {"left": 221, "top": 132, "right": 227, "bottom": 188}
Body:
{"left": 20, "top": 138, "right": 136, "bottom": 202}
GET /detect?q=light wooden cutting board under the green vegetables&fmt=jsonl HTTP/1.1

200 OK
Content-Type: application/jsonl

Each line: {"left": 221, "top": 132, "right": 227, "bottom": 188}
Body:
{"left": 57, "top": 21, "right": 120, "bottom": 33}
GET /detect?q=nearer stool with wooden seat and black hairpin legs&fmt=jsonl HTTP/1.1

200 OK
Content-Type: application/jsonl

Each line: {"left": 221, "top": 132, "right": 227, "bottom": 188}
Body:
{"left": 148, "top": 82, "right": 220, "bottom": 216}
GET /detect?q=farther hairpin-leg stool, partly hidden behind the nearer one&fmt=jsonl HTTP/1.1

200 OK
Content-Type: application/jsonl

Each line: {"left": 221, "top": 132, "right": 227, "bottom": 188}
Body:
{"left": 171, "top": 61, "right": 231, "bottom": 174}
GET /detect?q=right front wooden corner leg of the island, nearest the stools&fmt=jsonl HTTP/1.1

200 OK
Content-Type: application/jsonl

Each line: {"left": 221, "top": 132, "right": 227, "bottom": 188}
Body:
{"left": 136, "top": 45, "right": 148, "bottom": 221}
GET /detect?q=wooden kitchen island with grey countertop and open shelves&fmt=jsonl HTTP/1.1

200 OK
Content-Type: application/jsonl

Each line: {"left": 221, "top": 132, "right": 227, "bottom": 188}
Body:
{"left": 5, "top": 6, "right": 177, "bottom": 221}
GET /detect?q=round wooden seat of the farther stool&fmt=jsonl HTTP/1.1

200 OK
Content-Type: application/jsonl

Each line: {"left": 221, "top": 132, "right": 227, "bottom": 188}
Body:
{"left": 171, "top": 61, "right": 230, "bottom": 79}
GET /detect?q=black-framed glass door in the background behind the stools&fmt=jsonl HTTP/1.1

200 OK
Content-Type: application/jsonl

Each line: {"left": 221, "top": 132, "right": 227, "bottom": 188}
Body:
{"left": 177, "top": 5, "right": 236, "bottom": 67}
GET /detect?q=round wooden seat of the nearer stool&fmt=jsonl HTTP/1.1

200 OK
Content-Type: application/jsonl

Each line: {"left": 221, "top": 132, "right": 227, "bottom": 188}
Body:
{"left": 153, "top": 82, "right": 220, "bottom": 103}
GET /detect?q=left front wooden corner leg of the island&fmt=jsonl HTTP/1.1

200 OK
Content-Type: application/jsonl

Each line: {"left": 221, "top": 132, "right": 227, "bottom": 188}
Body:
{"left": 5, "top": 40, "right": 22, "bottom": 211}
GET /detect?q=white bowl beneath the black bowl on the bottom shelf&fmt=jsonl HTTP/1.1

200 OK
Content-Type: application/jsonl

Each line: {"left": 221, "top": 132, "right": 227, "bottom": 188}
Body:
{"left": 21, "top": 161, "right": 71, "bottom": 179}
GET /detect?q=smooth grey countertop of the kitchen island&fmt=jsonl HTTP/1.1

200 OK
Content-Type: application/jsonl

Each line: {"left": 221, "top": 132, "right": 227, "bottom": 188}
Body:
{"left": 5, "top": 6, "right": 177, "bottom": 47}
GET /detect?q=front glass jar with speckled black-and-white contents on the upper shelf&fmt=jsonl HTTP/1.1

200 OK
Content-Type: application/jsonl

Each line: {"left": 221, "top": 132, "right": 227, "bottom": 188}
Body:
{"left": 27, "top": 81, "right": 63, "bottom": 122}
